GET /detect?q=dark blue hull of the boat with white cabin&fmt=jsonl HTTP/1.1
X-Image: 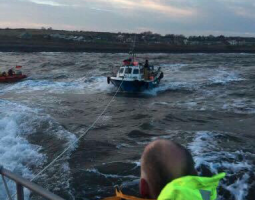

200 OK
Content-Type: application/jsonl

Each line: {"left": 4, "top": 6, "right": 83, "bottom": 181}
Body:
{"left": 110, "top": 78, "right": 160, "bottom": 92}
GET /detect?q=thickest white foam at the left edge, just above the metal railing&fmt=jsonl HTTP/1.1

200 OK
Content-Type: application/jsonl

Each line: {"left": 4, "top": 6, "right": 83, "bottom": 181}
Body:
{"left": 0, "top": 100, "right": 46, "bottom": 199}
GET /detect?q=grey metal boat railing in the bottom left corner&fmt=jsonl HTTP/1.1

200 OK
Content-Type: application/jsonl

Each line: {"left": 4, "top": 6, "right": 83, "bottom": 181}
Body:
{"left": 0, "top": 166, "right": 64, "bottom": 200}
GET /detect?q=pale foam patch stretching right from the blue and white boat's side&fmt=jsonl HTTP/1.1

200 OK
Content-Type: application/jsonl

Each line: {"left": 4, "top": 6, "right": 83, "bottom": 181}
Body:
{"left": 146, "top": 64, "right": 245, "bottom": 95}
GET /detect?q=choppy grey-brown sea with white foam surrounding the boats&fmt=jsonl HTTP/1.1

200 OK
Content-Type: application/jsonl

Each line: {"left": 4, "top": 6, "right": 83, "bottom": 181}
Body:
{"left": 0, "top": 53, "right": 255, "bottom": 200}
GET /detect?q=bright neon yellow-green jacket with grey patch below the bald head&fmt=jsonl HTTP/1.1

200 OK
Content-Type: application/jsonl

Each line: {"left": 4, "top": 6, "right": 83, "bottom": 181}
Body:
{"left": 158, "top": 173, "right": 226, "bottom": 200}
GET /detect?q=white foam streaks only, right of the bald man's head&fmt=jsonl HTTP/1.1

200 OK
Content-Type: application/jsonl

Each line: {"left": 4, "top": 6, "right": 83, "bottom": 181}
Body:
{"left": 188, "top": 131, "right": 254, "bottom": 200}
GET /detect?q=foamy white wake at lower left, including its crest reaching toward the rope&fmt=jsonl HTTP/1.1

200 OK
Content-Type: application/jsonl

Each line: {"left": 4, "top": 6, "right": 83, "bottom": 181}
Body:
{"left": 0, "top": 100, "right": 76, "bottom": 199}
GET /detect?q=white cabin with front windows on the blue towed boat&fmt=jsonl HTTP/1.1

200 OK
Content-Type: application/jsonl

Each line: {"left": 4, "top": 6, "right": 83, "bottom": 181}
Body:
{"left": 117, "top": 65, "right": 144, "bottom": 80}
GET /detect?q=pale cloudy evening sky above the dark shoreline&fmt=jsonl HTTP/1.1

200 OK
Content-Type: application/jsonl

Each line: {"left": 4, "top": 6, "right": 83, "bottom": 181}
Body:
{"left": 0, "top": 0, "right": 255, "bottom": 37}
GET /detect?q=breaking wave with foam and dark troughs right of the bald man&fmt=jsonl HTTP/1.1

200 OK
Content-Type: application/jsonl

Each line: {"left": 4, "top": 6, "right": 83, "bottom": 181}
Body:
{"left": 188, "top": 131, "right": 255, "bottom": 200}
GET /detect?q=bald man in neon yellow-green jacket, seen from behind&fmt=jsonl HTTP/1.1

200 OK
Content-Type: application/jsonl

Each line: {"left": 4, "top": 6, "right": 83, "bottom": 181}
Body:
{"left": 140, "top": 140, "right": 225, "bottom": 200}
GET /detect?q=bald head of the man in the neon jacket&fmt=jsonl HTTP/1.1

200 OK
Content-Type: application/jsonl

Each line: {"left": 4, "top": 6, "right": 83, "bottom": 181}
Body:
{"left": 141, "top": 140, "right": 196, "bottom": 198}
